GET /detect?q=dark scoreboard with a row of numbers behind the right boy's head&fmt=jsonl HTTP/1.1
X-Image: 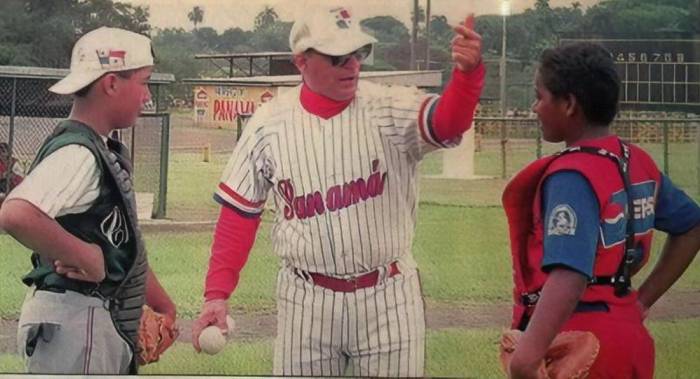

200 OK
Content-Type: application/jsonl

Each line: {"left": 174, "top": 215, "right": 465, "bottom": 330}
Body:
{"left": 560, "top": 39, "right": 700, "bottom": 112}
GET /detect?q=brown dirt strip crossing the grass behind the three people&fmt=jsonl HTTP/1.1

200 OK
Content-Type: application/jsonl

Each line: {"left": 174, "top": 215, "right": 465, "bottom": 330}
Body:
{"left": 0, "top": 290, "right": 700, "bottom": 354}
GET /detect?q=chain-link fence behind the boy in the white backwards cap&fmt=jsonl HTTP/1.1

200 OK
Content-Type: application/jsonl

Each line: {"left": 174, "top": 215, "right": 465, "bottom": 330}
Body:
{"left": 0, "top": 67, "right": 170, "bottom": 218}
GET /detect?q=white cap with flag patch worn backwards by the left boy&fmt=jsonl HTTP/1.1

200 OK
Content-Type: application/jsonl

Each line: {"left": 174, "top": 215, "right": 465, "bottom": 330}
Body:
{"left": 49, "top": 27, "right": 153, "bottom": 95}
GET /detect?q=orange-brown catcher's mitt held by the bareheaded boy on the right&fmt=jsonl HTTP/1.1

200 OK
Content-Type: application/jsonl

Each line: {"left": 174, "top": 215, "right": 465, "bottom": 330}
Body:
{"left": 500, "top": 330, "right": 600, "bottom": 379}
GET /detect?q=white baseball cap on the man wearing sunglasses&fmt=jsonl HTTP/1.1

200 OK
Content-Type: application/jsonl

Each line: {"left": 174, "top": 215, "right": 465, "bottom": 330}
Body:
{"left": 289, "top": 6, "right": 377, "bottom": 56}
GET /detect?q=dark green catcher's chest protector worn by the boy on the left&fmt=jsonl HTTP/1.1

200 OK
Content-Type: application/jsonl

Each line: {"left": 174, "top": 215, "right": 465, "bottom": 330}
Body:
{"left": 23, "top": 121, "right": 148, "bottom": 374}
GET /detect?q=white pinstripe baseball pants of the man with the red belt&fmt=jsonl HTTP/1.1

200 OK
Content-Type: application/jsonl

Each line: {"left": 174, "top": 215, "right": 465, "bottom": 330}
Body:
{"left": 273, "top": 268, "right": 425, "bottom": 377}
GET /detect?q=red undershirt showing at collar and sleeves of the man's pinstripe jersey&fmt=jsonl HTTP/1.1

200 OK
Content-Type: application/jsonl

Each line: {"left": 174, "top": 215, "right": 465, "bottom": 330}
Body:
{"left": 204, "top": 64, "right": 486, "bottom": 300}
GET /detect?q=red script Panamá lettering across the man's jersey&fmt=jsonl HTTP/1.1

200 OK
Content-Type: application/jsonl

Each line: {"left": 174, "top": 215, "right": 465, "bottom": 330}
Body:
{"left": 277, "top": 159, "right": 387, "bottom": 220}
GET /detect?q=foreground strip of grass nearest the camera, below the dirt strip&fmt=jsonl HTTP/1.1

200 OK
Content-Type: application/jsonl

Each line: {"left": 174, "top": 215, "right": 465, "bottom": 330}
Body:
{"left": 0, "top": 320, "right": 700, "bottom": 379}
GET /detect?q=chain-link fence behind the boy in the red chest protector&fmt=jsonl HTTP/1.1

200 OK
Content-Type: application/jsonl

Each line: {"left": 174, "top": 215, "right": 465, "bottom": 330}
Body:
{"left": 474, "top": 117, "right": 700, "bottom": 197}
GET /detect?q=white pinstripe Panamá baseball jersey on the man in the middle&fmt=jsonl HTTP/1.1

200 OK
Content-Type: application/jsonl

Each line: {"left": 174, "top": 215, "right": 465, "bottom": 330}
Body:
{"left": 215, "top": 82, "right": 459, "bottom": 276}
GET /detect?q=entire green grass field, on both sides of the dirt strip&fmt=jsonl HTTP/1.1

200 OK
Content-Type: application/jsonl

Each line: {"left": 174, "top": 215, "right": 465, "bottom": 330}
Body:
{"left": 0, "top": 140, "right": 700, "bottom": 378}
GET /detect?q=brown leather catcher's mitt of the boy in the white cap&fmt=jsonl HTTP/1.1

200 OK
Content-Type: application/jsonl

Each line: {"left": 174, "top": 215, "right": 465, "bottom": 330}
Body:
{"left": 138, "top": 305, "right": 180, "bottom": 365}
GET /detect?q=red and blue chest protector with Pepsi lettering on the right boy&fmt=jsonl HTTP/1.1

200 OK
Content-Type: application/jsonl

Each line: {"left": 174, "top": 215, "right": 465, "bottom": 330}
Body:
{"left": 503, "top": 136, "right": 661, "bottom": 327}
